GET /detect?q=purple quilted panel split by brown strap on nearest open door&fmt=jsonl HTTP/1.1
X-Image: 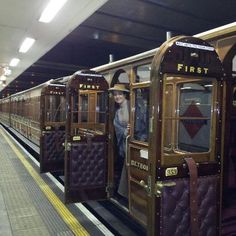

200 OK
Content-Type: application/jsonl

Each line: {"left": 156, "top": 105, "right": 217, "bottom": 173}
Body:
{"left": 161, "top": 176, "right": 219, "bottom": 236}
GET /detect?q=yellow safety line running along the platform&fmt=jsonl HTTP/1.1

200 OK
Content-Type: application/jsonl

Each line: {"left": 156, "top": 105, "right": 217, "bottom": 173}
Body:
{"left": 1, "top": 130, "right": 89, "bottom": 235}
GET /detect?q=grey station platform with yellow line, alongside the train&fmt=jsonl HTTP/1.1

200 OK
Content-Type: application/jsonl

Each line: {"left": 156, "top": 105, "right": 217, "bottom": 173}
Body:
{"left": 0, "top": 126, "right": 113, "bottom": 236}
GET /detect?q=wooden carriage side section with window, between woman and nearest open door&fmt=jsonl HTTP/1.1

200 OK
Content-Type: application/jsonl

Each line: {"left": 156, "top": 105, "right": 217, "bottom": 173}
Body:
{"left": 126, "top": 62, "right": 151, "bottom": 227}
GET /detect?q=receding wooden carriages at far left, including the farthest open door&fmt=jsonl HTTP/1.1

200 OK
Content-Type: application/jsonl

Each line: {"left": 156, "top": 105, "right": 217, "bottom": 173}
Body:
{"left": 0, "top": 78, "right": 65, "bottom": 172}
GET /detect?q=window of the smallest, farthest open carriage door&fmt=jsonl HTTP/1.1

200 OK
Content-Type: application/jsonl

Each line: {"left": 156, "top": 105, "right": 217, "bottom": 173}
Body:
{"left": 45, "top": 95, "right": 65, "bottom": 122}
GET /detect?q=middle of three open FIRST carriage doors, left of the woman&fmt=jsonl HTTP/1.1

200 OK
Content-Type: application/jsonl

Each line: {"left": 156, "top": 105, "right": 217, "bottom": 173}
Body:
{"left": 65, "top": 71, "right": 108, "bottom": 203}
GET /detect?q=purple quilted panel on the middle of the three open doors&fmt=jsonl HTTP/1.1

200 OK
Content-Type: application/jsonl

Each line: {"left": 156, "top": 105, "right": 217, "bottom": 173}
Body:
{"left": 70, "top": 142, "right": 106, "bottom": 187}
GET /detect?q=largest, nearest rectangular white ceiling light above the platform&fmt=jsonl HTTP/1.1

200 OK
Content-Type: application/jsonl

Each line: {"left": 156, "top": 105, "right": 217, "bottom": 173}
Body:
{"left": 39, "top": 0, "right": 67, "bottom": 23}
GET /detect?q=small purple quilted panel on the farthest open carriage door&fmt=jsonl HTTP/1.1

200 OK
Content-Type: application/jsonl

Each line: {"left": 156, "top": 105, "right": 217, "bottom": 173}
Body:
{"left": 43, "top": 130, "right": 65, "bottom": 162}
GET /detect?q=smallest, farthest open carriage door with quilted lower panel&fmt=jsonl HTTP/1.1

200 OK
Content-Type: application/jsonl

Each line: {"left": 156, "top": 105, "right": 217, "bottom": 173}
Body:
{"left": 40, "top": 84, "right": 66, "bottom": 173}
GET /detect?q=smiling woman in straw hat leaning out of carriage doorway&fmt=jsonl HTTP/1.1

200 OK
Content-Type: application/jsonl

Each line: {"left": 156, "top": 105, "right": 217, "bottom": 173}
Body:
{"left": 109, "top": 84, "right": 129, "bottom": 198}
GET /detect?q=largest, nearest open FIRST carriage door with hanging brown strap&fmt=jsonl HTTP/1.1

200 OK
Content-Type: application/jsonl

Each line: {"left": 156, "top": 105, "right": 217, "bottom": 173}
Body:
{"left": 147, "top": 37, "right": 224, "bottom": 236}
